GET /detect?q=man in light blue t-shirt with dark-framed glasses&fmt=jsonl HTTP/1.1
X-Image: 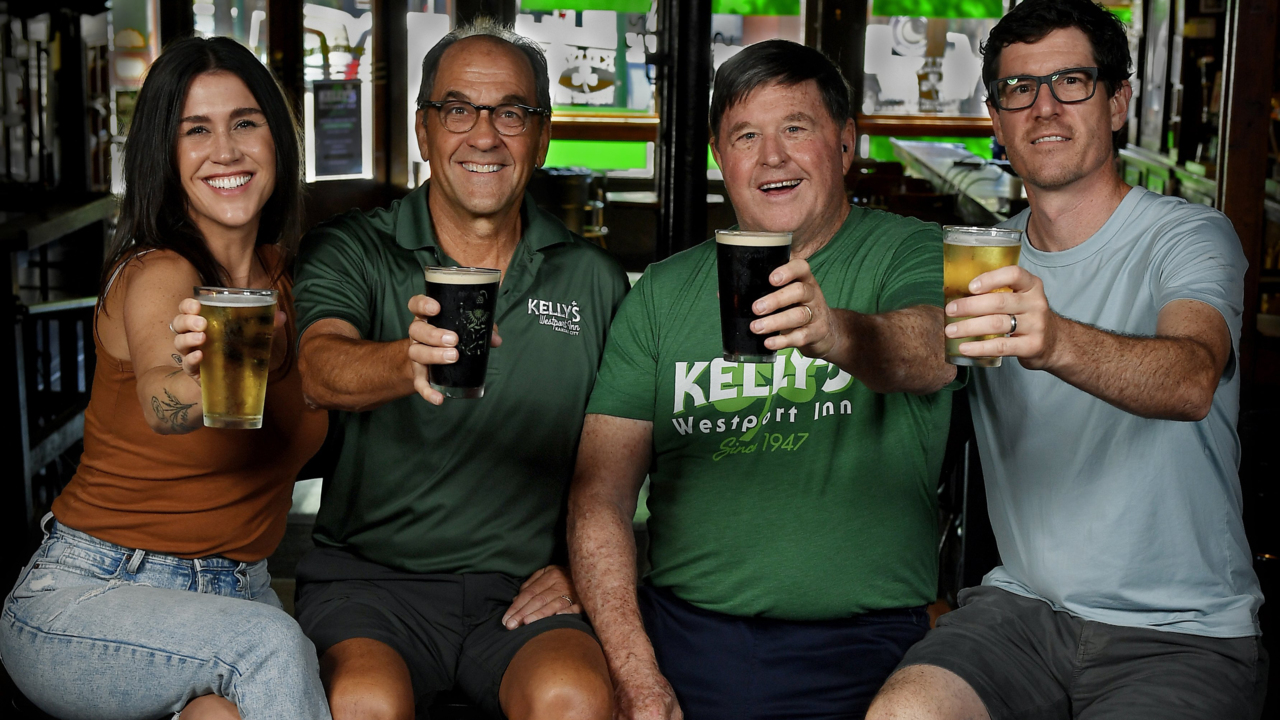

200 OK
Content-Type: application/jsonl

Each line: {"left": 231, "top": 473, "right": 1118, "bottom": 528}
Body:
{"left": 868, "top": 0, "right": 1267, "bottom": 720}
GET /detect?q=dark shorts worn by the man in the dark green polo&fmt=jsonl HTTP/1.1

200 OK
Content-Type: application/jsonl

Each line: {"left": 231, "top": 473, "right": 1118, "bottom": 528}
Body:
{"left": 296, "top": 548, "right": 595, "bottom": 717}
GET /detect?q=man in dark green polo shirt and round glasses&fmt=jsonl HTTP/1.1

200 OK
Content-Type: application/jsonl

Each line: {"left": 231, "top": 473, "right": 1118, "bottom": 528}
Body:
{"left": 294, "top": 22, "right": 627, "bottom": 720}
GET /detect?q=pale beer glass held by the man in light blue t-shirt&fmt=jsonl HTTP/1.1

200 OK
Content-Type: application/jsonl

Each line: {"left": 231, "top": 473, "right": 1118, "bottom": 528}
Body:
{"left": 942, "top": 225, "right": 1023, "bottom": 368}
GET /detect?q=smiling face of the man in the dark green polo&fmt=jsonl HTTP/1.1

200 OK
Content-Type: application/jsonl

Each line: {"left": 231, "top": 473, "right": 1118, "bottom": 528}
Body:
{"left": 416, "top": 36, "right": 550, "bottom": 218}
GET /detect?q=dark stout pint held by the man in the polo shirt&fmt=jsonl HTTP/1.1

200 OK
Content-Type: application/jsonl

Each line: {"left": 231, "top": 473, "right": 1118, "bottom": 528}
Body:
{"left": 426, "top": 266, "right": 502, "bottom": 398}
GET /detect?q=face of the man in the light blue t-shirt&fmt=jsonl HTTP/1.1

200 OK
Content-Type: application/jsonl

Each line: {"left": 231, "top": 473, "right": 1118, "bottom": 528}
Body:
{"left": 987, "top": 28, "right": 1133, "bottom": 190}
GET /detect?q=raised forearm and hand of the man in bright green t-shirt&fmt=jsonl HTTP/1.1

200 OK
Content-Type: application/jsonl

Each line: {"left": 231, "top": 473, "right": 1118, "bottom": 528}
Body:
{"left": 751, "top": 260, "right": 956, "bottom": 395}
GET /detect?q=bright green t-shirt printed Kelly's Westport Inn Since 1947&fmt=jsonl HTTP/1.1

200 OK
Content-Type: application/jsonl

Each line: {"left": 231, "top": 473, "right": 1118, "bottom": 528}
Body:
{"left": 588, "top": 208, "right": 951, "bottom": 620}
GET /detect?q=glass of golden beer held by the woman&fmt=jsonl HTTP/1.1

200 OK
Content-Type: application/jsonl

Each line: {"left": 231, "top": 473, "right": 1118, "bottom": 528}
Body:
{"left": 195, "top": 287, "right": 276, "bottom": 429}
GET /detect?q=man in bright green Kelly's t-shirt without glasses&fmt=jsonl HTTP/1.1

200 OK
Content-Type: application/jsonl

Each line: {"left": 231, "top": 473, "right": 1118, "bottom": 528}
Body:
{"left": 568, "top": 41, "right": 955, "bottom": 720}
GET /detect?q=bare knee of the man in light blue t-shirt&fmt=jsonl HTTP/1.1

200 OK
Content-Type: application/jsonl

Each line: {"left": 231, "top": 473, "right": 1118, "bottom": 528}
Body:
{"left": 867, "top": 665, "right": 989, "bottom": 720}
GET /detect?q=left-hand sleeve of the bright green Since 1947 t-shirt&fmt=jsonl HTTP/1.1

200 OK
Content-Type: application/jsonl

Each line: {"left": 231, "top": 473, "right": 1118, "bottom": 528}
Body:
{"left": 586, "top": 273, "right": 658, "bottom": 421}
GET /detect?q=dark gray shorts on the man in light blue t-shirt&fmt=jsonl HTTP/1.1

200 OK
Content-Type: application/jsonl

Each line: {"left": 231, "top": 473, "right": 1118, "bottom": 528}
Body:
{"left": 899, "top": 587, "right": 1267, "bottom": 720}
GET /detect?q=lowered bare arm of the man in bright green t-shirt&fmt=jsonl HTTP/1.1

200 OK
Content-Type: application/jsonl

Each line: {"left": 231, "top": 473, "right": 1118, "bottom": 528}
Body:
{"left": 568, "top": 415, "right": 682, "bottom": 720}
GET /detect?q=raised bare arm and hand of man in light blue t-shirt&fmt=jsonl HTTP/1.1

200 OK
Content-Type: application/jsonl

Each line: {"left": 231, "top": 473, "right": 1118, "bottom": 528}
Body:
{"left": 947, "top": 266, "right": 1231, "bottom": 421}
